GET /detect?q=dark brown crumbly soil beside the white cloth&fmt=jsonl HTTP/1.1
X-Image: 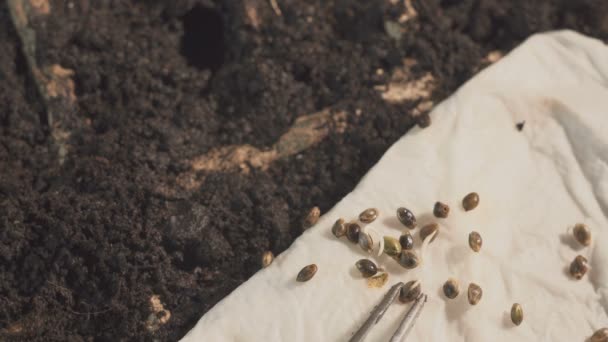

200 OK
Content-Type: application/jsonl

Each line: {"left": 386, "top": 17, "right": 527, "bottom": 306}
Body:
{"left": 0, "top": 0, "right": 608, "bottom": 341}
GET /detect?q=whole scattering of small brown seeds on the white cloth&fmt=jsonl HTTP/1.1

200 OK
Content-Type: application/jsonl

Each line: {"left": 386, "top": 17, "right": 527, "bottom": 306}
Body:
{"left": 280, "top": 192, "right": 608, "bottom": 336}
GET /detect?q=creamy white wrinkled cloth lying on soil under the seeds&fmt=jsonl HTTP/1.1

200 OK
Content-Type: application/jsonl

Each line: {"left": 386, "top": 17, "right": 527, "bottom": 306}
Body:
{"left": 182, "top": 31, "right": 608, "bottom": 342}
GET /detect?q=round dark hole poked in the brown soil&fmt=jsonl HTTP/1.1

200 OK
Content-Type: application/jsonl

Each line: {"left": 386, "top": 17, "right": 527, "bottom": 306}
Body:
{"left": 181, "top": 6, "right": 224, "bottom": 70}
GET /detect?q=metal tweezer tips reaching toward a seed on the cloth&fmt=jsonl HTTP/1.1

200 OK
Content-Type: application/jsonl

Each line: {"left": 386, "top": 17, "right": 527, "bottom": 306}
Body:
{"left": 349, "top": 282, "right": 427, "bottom": 342}
